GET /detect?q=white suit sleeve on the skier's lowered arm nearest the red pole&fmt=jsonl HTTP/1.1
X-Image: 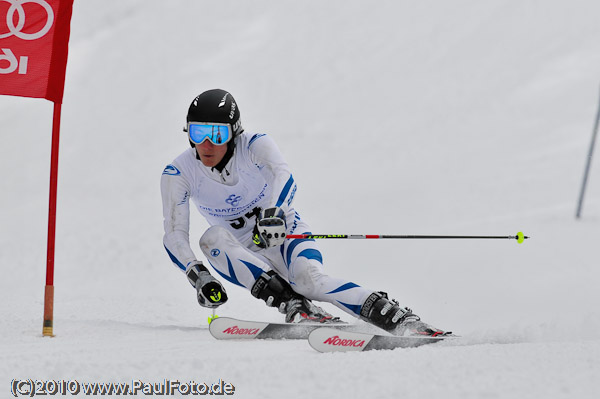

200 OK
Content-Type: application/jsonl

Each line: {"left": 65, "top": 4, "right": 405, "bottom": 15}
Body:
{"left": 160, "top": 165, "right": 196, "bottom": 272}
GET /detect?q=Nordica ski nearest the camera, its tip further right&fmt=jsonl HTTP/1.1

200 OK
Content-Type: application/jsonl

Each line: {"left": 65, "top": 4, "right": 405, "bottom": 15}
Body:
{"left": 308, "top": 327, "right": 445, "bottom": 352}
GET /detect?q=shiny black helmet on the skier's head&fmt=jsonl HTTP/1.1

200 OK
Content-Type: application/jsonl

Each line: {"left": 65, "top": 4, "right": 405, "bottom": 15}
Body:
{"left": 186, "top": 89, "right": 244, "bottom": 141}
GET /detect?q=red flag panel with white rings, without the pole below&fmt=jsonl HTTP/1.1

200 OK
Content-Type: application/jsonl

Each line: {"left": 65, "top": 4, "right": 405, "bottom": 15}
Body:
{"left": 0, "top": 0, "right": 73, "bottom": 104}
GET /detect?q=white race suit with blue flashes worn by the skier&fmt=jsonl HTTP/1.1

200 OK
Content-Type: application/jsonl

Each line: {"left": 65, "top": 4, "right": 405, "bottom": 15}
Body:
{"left": 161, "top": 133, "right": 373, "bottom": 316}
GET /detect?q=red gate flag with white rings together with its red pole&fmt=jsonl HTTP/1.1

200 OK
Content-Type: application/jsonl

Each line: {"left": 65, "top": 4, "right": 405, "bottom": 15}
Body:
{"left": 0, "top": 0, "right": 73, "bottom": 336}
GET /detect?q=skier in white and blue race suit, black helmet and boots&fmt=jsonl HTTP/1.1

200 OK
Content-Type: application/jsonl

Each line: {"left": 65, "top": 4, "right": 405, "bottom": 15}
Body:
{"left": 161, "top": 89, "right": 443, "bottom": 336}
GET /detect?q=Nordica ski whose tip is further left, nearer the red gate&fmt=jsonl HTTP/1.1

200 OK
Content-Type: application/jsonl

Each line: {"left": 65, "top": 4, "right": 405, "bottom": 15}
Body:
{"left": 209, "top": 317, "right": 350, "bottom": 339}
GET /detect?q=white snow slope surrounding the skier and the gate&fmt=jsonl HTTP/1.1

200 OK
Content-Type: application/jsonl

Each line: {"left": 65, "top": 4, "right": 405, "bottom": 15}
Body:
{"left": 0, "top": 0, "right": 600, "bottom": 399}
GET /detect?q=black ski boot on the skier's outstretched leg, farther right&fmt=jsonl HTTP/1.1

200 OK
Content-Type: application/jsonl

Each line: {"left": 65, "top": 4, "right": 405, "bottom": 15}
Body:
{"left": 360, "top": 292, "right": 450, "bottom": 337}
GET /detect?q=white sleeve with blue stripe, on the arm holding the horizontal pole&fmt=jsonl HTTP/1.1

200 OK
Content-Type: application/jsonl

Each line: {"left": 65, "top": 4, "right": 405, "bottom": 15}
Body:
{"left": 248, "top": 134, "right": 296, "bottom": 213}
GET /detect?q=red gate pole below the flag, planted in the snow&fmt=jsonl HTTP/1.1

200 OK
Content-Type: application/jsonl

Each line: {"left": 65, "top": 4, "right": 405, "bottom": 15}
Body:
{"left": 42, "top": 102, "right": 62, "bottom": 337}
